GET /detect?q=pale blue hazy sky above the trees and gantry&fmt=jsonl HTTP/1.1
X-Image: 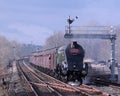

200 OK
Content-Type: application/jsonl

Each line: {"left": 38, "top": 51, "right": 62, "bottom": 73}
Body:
{"left": 0, "top": 0, "right": 120, "bottom": 45}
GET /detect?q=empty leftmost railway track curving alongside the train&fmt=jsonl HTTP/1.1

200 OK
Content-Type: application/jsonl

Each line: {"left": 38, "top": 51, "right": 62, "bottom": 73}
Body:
{"left": 18, "top": 61, "right": 78, "bottom": 96}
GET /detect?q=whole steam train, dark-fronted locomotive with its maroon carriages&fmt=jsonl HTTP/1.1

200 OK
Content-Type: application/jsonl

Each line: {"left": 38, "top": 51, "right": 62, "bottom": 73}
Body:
{"left": 30, "top": 41, "right": 88, "bottom": 85}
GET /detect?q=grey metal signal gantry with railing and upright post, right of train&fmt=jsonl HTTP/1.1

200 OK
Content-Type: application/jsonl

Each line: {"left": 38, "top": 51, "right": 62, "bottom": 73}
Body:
{"left": 64, "top": 24, "right": 116, "bottom": 82}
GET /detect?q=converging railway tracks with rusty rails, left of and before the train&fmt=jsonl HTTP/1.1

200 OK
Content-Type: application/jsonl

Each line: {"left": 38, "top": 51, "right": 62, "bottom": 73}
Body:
{"left": 17, "top": 62, "right": 108, "bottom": 96}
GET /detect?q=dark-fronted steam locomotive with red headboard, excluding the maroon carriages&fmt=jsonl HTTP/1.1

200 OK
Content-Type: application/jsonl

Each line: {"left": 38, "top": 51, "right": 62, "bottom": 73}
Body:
{"left": 55, "top": 42, "right": 88, "bottom": 84}
